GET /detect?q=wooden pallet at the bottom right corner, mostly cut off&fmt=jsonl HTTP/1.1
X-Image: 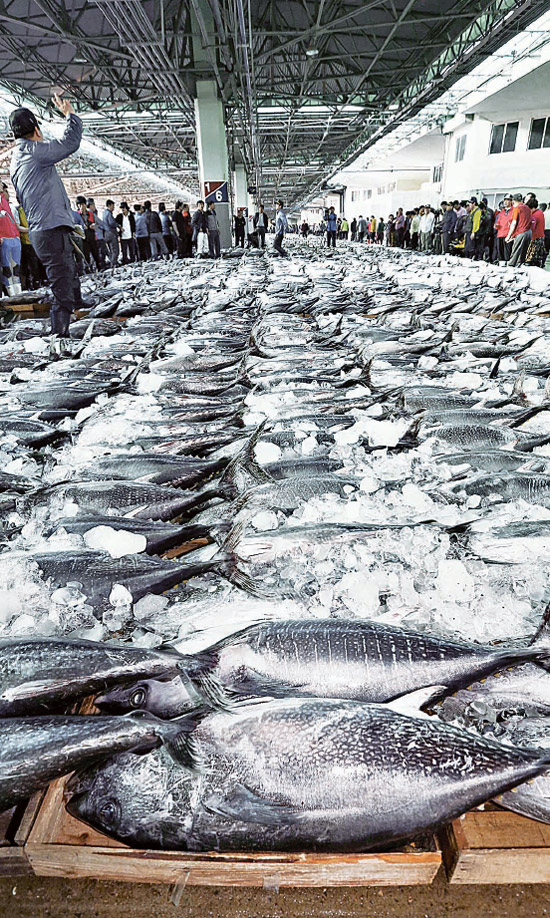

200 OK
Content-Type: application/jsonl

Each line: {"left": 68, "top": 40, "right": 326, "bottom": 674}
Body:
{"left": 440, "top": 807, "right": 550, "bottom": 884}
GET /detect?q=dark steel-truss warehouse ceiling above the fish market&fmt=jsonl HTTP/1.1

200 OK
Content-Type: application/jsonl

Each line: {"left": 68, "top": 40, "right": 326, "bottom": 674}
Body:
{"left": 0, "top": 0, "right": 550, "bottom": 205}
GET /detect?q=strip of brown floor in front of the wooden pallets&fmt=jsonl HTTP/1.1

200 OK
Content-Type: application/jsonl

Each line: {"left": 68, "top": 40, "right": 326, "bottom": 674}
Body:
{"left": 0, "top": 876, "right": 550, "bottom": 918}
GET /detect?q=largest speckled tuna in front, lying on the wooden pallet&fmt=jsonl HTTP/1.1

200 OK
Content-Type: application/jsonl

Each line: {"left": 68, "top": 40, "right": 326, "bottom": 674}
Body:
{"left": 68, "top": 693, "right": 550, "bottom": 851}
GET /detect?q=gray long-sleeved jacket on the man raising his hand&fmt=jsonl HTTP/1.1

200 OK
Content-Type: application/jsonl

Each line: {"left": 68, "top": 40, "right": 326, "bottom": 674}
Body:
{"left": 10, "top": 115, "right": 82, "bottom": 233}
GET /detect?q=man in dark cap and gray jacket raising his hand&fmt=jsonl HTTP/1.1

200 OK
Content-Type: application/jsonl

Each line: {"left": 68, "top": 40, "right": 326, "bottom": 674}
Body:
{"left": 10, "top": 96, "right": 82, "bottom": 338}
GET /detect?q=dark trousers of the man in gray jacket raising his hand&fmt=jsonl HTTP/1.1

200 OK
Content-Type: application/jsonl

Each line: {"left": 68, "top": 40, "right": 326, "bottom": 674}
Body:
{"left": 31, "top": 226, "right": 82, "bottom": 338}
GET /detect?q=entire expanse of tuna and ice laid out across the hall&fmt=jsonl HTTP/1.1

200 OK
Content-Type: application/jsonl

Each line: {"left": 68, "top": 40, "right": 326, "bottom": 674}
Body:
{"left": 0, "top": 245, "right": 550, "bottom": 850}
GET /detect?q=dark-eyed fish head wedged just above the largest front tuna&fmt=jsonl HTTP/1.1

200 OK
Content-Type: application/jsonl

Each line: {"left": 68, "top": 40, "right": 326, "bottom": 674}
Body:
{"left": 95, "top": 673, "right": 199, "bottom": 719}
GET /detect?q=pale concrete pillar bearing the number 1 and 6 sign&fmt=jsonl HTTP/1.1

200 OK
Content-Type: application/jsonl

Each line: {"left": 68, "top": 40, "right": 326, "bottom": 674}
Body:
{"left": 195, "top": 80, "right": 231, "bottom": 248}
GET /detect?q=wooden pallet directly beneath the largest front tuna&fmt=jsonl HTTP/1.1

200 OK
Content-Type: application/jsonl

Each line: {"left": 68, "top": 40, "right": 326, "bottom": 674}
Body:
{"left": 25, "top": 778, "right": 441, "bottom": 889}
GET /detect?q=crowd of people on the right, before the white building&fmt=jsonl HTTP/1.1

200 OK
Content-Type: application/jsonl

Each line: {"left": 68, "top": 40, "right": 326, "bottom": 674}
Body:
{"left": 330, "top": 192, "right": 550, "bottom": 268}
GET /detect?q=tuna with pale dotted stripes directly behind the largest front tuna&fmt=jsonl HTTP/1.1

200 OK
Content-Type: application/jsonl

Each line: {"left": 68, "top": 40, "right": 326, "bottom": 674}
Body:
{"left": 100, "top": 619, "right": 550, "bottom": 717}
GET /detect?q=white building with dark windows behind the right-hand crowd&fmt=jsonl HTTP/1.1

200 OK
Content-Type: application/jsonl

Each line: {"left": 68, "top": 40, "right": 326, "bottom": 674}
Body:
{"left": 324, "top": 63, "right": 550, "bottom": 220}
